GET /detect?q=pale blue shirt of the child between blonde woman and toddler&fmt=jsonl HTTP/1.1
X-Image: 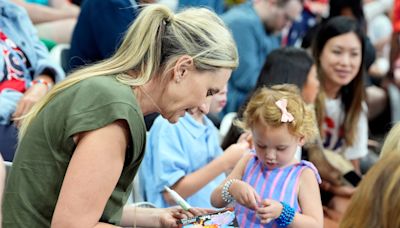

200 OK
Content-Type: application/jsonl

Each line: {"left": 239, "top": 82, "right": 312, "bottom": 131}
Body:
{"left": 139, "top": 114, "right": 226, "bottom": 208}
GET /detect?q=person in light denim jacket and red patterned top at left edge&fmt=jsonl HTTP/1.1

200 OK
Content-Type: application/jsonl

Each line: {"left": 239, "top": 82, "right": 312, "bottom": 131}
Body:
{"left": 0, "top": 0, "right": 64, "bottom": 161}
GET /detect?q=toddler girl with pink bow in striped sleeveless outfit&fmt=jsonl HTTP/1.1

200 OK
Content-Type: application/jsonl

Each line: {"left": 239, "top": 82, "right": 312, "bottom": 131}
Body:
{"left": 211, "top": 84, "right": 323, "bottom": 227}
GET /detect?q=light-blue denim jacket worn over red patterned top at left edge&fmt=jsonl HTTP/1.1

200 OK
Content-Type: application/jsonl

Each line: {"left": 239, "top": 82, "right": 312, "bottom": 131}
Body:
{"left": 0, "top": 0, "right": 65, "bottom": 125}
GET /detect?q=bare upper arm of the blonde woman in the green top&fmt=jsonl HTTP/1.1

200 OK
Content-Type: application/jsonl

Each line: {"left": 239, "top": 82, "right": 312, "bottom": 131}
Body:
{"left": 51, "top": 120, "right": 130, "bottom": 228}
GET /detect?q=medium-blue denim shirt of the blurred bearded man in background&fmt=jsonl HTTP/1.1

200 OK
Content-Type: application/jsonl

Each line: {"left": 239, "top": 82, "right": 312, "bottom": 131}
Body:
{"left": 221, "top": 2, "right": 280, "bottom": 115}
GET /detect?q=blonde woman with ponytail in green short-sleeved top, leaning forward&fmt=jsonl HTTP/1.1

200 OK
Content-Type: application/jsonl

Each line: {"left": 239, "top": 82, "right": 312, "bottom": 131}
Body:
{"left": 3, "top": 4, "right": 238, "bottom": 228}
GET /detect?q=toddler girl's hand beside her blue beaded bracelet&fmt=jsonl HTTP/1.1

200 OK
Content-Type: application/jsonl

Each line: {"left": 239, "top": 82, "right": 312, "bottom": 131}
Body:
{"left": 256, "top": 199, "right": 283, "bottom": 224}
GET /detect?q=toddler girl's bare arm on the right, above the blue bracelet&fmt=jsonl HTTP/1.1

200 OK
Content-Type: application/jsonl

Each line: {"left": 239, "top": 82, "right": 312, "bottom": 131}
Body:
{"left": 290, "top": 169, "right": 323, "bottom": 228}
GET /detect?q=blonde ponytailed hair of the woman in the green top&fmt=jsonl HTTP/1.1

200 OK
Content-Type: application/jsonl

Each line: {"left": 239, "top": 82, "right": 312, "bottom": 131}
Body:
{"left": 19, "top": 4, "right": 238, "bottom": 138}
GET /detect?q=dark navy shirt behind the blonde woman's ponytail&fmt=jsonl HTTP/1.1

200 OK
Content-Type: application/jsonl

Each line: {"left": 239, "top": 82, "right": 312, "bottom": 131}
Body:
{"left": 67, "top": 0, "right": 137, "bottom": 71}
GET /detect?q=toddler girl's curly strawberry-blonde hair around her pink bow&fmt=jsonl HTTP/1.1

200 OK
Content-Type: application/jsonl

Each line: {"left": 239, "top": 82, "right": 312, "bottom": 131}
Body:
{"left": 235, "top": 84, "right": 318, "bottom": 141}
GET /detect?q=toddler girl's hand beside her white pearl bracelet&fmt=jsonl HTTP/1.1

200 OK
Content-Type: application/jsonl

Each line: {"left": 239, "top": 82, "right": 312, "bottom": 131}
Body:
{"left": 229, "top": 180, "right": 260, "bottom": 210}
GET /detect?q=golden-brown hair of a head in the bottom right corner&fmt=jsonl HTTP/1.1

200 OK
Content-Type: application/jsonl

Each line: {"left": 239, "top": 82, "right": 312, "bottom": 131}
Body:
{"left": 340, "top": 151, "right": 400, "bottom": 228}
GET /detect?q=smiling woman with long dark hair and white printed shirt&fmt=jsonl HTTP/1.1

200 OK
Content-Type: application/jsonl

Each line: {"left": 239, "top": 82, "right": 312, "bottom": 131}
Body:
{"left": 313, "top": 16, "right": 368, "bottom": 226}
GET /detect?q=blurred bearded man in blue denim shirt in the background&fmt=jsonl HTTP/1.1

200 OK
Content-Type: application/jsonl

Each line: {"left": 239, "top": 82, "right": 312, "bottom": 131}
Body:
{"left": 220, "top": 0, "right": 303, "bottom": 117}
